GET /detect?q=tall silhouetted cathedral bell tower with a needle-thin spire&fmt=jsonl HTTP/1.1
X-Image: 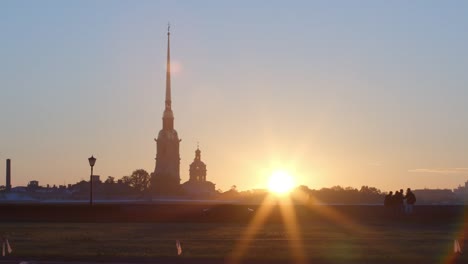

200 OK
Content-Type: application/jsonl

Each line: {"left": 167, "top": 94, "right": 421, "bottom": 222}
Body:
{"left": 151, "top": 28, "right": 181, "bottom": 195}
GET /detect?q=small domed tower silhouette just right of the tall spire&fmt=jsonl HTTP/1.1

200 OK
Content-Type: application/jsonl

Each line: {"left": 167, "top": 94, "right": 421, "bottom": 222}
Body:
{"left": 182, "top": 147, "right": 216, "bottom": 196}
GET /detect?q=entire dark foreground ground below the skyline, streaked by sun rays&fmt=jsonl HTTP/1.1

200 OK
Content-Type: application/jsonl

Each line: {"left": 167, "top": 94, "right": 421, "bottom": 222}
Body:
{"left": 0, "top": 204, "right": 468, "bottom": 264}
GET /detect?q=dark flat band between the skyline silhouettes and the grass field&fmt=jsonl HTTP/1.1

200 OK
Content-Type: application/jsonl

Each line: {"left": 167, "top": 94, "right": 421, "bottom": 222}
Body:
{"left": 0, "top": 203, "right": 468, "bottom": 223}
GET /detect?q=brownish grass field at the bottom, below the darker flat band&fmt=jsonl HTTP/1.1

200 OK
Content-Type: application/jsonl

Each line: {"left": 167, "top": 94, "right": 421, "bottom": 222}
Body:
{"left": 0, "top": 222, "right": 468, "bottom": 263}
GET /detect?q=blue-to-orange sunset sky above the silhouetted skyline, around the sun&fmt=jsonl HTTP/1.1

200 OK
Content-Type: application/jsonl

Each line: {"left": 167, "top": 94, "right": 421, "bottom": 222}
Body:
{"left": 0, "top": 0, "right": 468, "bottom": 191}
